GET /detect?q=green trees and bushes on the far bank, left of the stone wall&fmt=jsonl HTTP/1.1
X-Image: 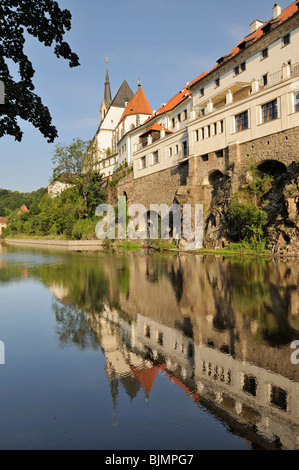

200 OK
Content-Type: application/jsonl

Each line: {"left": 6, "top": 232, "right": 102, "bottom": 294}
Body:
{"left": 3, "top": 139, "right": 107, "bottom": 239}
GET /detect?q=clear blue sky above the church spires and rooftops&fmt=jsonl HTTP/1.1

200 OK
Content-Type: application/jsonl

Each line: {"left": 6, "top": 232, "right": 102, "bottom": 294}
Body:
{"left": 0, "top": 0, "right": 292, "bottom": 193}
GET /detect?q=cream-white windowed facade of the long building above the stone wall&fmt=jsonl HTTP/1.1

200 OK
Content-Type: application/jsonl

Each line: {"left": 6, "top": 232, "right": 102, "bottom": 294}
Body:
{"left": 133, "top": 2, "right": 299, "bottom": 183}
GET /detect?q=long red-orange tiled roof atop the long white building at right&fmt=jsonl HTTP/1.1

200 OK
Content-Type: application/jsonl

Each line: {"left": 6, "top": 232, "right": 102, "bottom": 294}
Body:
{"left": 189, "top": 0, "right": 299, "bottom": 86}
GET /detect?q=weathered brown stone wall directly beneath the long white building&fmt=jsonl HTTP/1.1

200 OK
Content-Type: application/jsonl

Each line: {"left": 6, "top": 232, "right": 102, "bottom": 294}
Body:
{"left": 117, "top": 127, "right": 299, "bottom": 207}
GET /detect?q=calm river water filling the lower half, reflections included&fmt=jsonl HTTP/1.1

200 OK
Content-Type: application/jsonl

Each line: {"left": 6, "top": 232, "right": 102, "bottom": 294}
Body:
{"left": 0, "top": 245, "right": 299, "bottom": 450}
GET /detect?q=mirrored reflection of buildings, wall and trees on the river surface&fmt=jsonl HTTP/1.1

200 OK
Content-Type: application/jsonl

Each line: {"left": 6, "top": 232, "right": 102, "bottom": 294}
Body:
{"left": 0, "top": 244, "right": 299, "bottom": 449}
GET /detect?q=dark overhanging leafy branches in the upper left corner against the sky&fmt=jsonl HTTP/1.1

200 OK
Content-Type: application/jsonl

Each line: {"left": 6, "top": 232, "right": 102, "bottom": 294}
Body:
{"left": 0, "top": 0, "right": 80, "bottom": 142}
